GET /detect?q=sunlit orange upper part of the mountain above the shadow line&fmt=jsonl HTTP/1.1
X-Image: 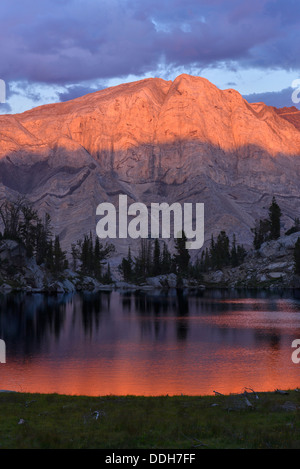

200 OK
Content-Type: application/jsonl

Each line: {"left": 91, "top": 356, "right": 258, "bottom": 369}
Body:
{"left": 0, "top": 74, "right": 300, "bottom": 160}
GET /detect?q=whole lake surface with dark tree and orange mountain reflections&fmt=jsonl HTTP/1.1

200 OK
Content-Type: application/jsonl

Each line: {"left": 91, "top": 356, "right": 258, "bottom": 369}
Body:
{"left": 0, "top": 290, "right": 300, "bottom": 395}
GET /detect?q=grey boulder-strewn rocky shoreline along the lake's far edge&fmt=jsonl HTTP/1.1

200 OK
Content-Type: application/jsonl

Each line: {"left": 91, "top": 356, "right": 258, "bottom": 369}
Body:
{"left": 0, "top": 233, "right": 300, "bottom": 294}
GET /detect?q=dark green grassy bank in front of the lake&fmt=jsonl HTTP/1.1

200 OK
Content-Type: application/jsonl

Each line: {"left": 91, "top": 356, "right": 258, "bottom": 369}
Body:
{"left": 0, "top": 391, "right": 300, "bottom": 449}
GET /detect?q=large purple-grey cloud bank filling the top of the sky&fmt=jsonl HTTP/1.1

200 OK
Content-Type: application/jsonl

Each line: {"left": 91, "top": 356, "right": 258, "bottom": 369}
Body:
{"left": 0, "top": 0, "right": 300, "bottom": 84}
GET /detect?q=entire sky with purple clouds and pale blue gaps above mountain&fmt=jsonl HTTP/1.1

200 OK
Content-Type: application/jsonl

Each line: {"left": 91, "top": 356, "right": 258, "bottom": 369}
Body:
{"left": 0, "top": 0, "right": 300, "bottom": 114}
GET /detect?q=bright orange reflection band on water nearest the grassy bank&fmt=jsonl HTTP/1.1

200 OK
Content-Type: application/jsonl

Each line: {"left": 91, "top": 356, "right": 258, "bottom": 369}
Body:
{"left": 0, "top": 340, "right": 300, "bottom": 396}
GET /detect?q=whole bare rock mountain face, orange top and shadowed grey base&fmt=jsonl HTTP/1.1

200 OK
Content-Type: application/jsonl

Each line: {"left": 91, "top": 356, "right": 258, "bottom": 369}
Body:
{"left": 0, "top": 75, "right": 300, "bottom": 251}
